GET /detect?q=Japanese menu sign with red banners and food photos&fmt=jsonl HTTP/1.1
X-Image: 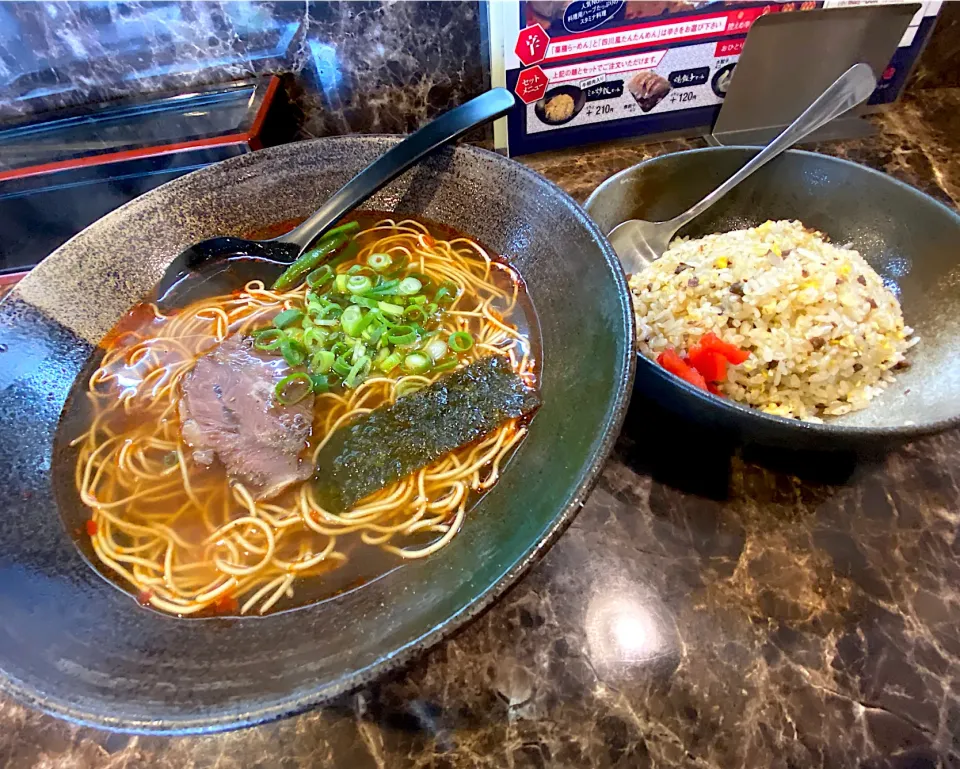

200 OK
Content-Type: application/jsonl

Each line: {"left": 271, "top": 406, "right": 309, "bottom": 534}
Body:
{"left": 487, "top": 0, "right": 941, "bottom": 155}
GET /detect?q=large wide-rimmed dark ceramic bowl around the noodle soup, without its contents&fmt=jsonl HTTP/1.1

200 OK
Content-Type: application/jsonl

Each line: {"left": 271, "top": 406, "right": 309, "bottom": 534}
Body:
{"left": 0, "top": 137, "right": 635, "bottom": 733}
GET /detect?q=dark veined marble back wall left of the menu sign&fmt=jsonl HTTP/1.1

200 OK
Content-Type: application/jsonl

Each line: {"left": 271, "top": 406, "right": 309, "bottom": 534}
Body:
{"left": 0, "top": 0, "right": 489, "bottom": 136}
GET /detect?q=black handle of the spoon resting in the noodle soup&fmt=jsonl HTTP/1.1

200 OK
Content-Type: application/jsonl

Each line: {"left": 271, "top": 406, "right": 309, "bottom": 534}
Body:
{"left": 277, "top": 88, "right": 514, "bottom": 253}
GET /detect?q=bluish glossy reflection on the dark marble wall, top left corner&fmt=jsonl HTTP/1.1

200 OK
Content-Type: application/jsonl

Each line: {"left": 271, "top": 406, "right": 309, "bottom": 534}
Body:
{"left": 0, "top": 1, "right": 306, "bottom": 118}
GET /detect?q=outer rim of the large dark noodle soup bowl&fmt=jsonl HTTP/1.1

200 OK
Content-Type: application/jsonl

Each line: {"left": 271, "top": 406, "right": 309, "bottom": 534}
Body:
{"left": 0, "top": 134, "right": 636, "bottom": 736}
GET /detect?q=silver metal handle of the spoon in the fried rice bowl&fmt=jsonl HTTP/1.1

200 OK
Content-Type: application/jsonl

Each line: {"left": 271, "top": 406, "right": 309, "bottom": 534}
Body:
{"left": 670, "top": 63, "right": 877, "bottom": 232}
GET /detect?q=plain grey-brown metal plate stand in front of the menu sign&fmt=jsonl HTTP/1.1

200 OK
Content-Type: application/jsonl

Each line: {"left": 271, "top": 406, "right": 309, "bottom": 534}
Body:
{"left": 706, "top": 4, "right": 921, "bottom": 146}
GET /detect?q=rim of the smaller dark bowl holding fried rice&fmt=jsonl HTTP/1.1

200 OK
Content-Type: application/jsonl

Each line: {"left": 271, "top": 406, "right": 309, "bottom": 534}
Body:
{"left": 583, "top": 144, "right": 960, "bottom": 442}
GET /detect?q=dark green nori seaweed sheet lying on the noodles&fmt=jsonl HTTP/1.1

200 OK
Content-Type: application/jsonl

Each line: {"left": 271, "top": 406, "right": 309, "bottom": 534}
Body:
{"left": 315, "top": 355, "right": 540, "bottom": 513}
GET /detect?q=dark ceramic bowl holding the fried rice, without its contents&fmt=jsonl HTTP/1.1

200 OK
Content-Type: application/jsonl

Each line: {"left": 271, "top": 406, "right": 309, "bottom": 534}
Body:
{"left": 586, "top": 147, "right": 960, "bottom": 449}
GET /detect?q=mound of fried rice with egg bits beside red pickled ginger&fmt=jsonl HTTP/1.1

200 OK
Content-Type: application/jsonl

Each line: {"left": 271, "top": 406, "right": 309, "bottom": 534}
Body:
{"left": 630, "top": 221, "right": 919, "bottom": 421}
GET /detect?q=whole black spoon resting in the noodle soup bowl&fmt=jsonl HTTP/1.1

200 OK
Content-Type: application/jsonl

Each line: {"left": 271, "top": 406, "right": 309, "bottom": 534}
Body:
{"left": 156, "top": 88, "right": 514, "bottom": 310}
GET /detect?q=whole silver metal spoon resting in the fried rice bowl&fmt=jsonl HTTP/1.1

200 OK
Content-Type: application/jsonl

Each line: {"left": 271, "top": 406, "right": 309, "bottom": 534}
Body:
{"left": 607, "top": 63, "right": 877, "bottom": 274}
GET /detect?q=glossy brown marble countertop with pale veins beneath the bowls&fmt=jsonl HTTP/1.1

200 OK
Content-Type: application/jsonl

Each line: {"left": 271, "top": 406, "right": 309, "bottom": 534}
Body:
{"left": 0, "top": 89, "right": 960, "bottom": 769}
